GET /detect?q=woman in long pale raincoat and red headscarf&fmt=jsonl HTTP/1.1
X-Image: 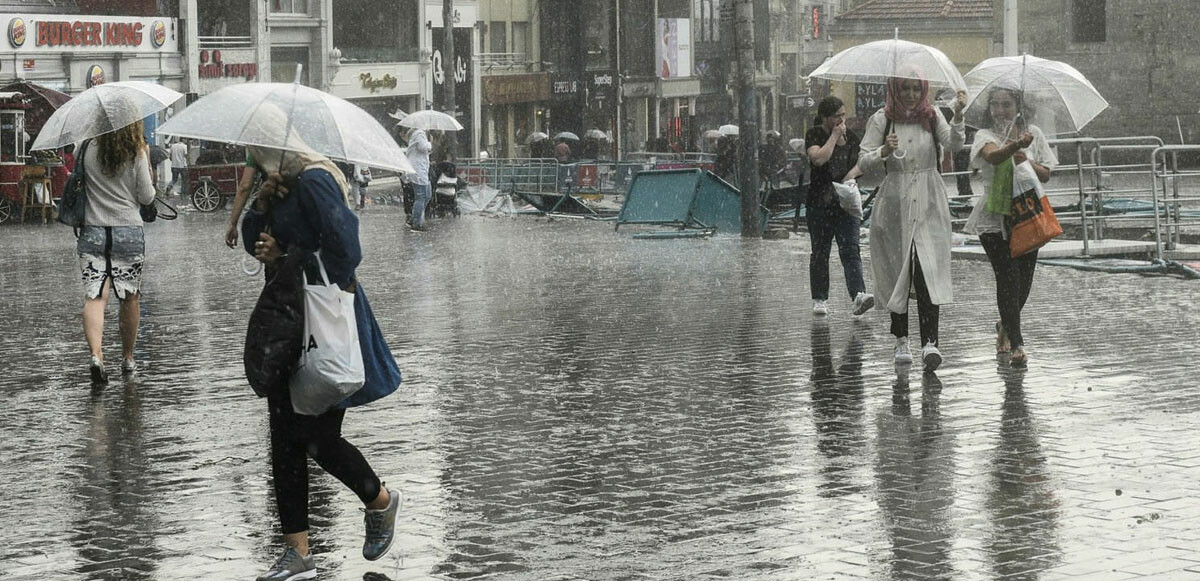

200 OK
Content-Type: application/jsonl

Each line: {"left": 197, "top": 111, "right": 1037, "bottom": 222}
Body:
{"left": 858, "top": 77, "right": 966, "bottom": 371}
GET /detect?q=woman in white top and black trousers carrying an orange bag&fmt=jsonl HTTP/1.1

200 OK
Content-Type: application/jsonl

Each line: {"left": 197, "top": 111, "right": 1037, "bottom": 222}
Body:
{"left": 964, "top": 89, "right": 1058, "bottom": 367}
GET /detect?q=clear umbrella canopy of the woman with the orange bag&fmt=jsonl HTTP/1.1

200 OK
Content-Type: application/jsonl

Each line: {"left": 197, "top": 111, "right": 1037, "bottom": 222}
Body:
{"left": 964, "top": 55, "right": 1109, "bottom": 136}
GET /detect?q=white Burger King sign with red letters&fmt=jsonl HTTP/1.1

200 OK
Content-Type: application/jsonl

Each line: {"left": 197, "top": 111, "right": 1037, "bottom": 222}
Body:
{"left": 0, "top": 14, "right": 179, "bottom": 54}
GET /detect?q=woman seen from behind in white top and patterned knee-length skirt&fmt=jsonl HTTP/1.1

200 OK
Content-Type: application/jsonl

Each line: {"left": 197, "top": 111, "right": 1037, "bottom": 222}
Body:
{"left": 76, "top": 115, "right": 155, "bottom": 383}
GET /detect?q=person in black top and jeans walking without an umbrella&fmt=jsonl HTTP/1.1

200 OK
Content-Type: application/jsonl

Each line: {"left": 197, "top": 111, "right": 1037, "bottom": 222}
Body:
{"left": 804, "top": 96, "right": 875, "bottom": 316}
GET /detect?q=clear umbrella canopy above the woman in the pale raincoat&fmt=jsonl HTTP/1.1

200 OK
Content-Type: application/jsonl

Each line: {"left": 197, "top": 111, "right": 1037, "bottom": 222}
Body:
{"left": 809, "top": 38, "right": 966, "bottom": 90}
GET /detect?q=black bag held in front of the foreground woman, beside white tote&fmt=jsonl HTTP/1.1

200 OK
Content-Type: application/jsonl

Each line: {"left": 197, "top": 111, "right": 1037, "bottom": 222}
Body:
{"left": 242, "top": 247, "right": 307, "bottom": 397}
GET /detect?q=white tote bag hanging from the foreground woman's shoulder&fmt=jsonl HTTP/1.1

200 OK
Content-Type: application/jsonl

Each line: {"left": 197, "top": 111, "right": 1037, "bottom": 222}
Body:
{"left": 289, "top": 252, "right": 366, "bottom": 415}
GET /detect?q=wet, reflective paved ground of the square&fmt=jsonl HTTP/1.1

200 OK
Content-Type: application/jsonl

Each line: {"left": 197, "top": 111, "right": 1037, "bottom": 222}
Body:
{"left": 0, "top": 208, "right": 1200, "bottom": 581}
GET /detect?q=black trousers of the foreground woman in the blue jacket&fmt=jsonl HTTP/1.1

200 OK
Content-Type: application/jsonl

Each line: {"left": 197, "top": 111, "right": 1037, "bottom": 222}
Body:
{"left": 266, "top": 394, "right": 380, "bottom": 534}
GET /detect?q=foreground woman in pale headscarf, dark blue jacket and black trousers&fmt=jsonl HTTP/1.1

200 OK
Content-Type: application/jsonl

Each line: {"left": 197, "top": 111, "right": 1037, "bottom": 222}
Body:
{"left": 241, "top": 108, "right": 400, "bottom": 581}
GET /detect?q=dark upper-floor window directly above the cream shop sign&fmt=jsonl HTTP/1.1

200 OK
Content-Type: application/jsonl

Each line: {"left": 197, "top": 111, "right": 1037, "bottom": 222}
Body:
{"left": 332, "top": 0, "right": 419, "bottom": 62}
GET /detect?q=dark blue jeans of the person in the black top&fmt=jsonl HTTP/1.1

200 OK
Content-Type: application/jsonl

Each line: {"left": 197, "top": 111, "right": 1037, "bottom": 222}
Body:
{"left": 806, "top": 205, "right": 866, "bottom": 300}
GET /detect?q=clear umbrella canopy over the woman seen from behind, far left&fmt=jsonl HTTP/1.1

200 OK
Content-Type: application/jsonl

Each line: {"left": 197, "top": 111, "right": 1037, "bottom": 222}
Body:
{"left": 30, "top": 80, "right": 184, "bottom": 150}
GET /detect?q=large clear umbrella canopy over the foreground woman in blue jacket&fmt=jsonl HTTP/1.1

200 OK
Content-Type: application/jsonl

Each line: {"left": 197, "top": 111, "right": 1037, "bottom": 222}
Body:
{"left": 158, "top": 83, "right": 413, "bottom": 173}
